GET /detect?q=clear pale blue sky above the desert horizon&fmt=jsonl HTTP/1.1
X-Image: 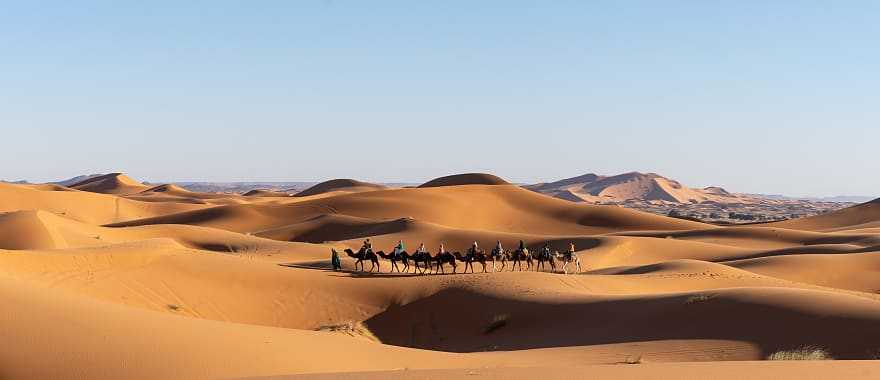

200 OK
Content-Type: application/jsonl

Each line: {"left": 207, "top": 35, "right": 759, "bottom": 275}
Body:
{"left": 0, "top": 0, "right": 880, "bottom": 196}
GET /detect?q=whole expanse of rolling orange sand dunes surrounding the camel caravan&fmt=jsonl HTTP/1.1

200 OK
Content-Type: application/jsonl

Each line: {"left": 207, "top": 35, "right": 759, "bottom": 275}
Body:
{"left": 0, "top": 180, "right": 880, "bottom": 378}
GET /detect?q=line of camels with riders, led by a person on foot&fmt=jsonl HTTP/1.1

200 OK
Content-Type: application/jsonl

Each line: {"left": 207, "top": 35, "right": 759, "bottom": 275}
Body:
{"left": 331, "top": 239, "right": 581, "bottom": 274}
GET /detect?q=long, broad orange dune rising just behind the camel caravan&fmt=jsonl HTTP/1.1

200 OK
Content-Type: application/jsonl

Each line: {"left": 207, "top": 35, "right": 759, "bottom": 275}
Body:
{"left": 113, "top": 185, "right": 712, "bottom": 235}
